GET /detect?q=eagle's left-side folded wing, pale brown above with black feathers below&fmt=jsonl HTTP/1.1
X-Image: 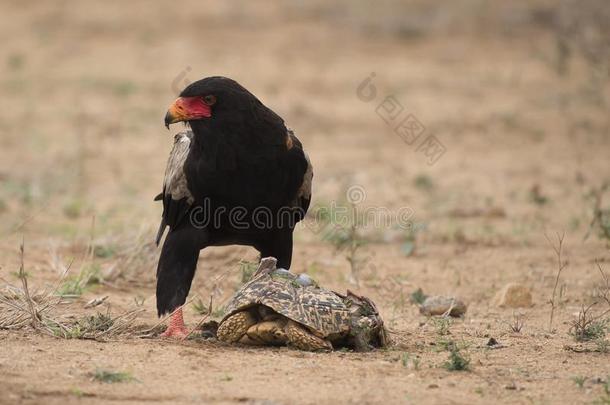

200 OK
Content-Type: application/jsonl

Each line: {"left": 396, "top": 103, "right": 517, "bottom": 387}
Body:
{"left": 155, "top": 131, "right": 194, "bottom": 245}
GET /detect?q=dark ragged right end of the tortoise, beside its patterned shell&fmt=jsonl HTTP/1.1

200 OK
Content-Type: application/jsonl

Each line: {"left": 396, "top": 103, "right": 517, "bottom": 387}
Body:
{"left": 345, "top": 290, "right": 390, "bottom": 351}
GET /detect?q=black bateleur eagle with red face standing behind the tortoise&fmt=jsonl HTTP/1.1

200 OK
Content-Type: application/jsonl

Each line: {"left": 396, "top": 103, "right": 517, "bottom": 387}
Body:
{"left": 156, "top": 77, "right": 313, "bottom": 337}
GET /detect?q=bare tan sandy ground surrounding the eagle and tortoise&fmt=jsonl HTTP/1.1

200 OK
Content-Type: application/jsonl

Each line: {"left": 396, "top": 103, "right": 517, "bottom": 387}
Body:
{"left": 0, "top": 0, "right": 610, "bottom": 404}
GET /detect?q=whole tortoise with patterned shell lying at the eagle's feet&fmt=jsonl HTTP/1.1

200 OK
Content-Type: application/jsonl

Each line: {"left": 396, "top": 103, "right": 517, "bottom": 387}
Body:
{"left": 217, "top": 257, "right": 389, "bottom": 351}
